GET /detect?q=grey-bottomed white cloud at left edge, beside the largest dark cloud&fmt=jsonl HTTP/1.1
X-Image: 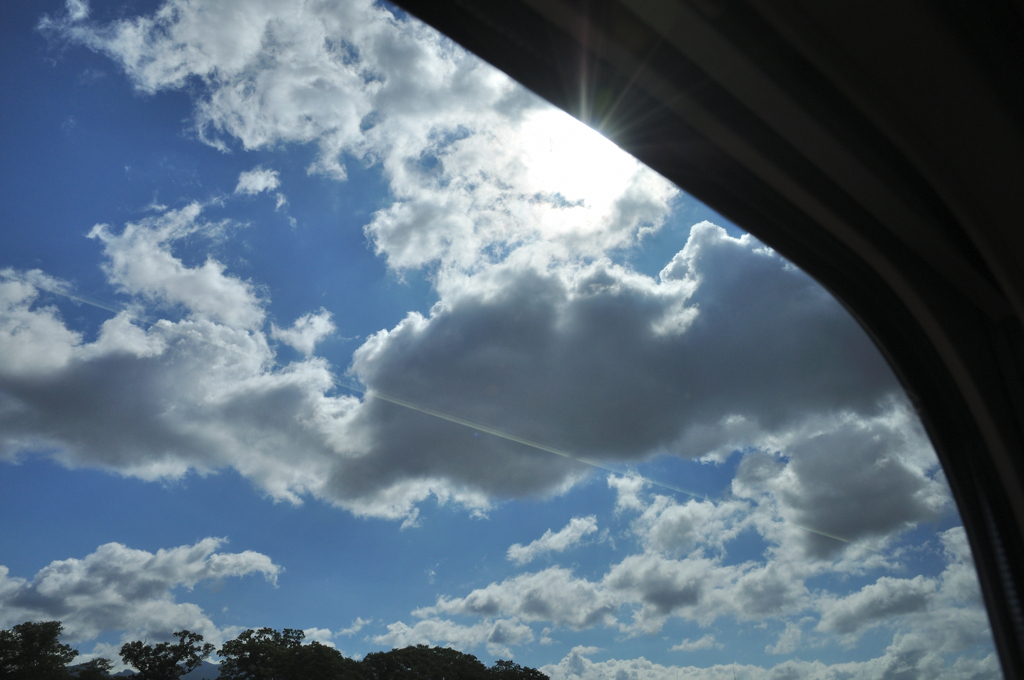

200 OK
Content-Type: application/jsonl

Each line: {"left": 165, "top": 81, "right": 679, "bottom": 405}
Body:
{"left": 0, "top": 206, "right": 354, "bottom": 501}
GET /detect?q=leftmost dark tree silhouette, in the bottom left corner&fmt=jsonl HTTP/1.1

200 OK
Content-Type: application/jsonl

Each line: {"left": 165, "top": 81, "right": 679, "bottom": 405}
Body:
{"left": 0, "top": 621, "right": 78, "bottom": 680}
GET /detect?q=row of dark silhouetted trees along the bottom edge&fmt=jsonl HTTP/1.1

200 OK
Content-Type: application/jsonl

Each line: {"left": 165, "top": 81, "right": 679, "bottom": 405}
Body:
{"left": 0, "top": 621, "right": 548, "bottom": 680}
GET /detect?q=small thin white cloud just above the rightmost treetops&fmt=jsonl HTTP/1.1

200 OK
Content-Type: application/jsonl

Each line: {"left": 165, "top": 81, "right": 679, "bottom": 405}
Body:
{"left": 373, "top": 619, "right": 534, "bottom": 658}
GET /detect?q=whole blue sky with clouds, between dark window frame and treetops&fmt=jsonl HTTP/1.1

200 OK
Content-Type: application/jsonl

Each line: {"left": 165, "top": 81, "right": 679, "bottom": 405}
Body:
{"left": 0, "top": 0, "right": 999, "bottom": 680}
